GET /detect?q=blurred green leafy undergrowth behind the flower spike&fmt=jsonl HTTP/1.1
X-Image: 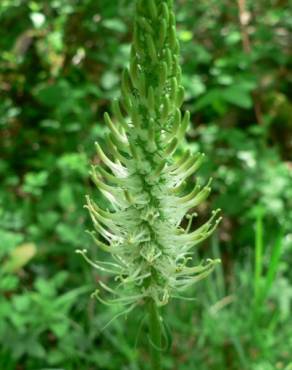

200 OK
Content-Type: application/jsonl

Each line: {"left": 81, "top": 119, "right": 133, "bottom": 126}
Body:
{"left": 0, "top": 0, "right": 292, "bottom": 370}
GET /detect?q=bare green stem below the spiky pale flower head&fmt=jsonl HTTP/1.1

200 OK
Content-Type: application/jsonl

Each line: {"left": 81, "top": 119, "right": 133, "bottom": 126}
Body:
{"left": 148, "top": 299, "right": 162, "bottom": 370}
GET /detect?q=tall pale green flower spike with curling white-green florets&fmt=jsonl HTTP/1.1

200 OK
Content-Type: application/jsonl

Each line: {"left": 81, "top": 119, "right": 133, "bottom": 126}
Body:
{"left": 78, "top": 0, "right": 220, "bottom": 308}
